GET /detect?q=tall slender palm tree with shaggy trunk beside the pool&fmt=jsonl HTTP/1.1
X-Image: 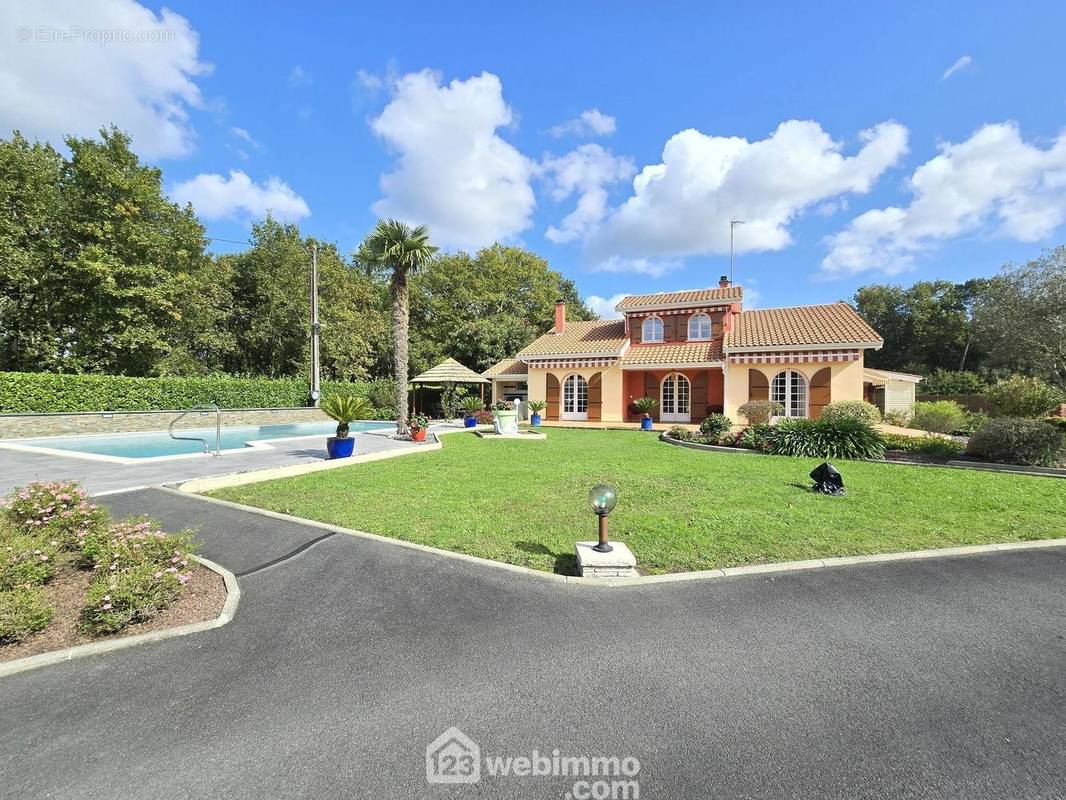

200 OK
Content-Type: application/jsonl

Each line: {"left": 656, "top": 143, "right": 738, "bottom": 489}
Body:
{"left": 356, "top": 220, "right": 437, "bottom": 436}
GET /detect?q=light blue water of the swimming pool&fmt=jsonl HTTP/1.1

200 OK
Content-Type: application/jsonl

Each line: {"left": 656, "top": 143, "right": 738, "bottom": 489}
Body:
{"left": 10, "top": 422, "right": 392, "bottom": 459}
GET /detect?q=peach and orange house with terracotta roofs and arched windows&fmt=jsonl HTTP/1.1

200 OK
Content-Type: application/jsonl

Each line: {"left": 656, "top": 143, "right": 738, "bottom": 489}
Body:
{"left": 484, "top": 277, "right": 883, "bottom": 423}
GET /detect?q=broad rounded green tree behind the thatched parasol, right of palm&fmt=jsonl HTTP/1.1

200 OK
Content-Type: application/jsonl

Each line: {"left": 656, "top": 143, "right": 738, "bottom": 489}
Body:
{"left": 411, "top": 244, "right": 594, "bottom": 371}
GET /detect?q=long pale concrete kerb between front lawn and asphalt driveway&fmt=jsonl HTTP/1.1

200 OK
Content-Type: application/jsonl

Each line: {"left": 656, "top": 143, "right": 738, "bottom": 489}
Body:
{"left": 179, "top": 486, "right": 1066, "bottom": 588}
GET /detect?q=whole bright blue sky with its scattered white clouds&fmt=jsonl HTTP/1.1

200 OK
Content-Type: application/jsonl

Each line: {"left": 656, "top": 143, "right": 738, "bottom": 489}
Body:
{"left": 0, "top": 0, "right": 1066, "bottom": 315}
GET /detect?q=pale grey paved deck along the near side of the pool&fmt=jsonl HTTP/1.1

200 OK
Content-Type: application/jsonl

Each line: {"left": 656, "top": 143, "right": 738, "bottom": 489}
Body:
{"left": 0, "top": 430, "right": 418, "bottom": 495}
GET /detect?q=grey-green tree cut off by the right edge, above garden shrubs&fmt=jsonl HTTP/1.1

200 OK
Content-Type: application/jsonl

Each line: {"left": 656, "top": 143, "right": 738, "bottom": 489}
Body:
{"left": 974, "top": 246, "right": 1066, "bottom": 389}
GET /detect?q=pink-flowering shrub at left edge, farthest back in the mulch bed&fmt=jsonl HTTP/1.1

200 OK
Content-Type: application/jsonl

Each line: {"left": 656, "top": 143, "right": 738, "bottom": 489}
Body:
{"left": 3, "top": 481, "right": 108, "bottom": 550}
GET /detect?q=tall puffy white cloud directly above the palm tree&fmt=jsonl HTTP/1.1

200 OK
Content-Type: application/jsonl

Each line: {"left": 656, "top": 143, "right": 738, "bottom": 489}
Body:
{"left": 370, "top": 69, "right": 536, "bottom": 249}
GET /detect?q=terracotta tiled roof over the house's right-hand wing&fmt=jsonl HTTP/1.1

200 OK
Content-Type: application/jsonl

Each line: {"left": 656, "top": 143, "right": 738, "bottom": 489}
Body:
{"left": 725, "top": 303, "right": 882, "bottom": 350}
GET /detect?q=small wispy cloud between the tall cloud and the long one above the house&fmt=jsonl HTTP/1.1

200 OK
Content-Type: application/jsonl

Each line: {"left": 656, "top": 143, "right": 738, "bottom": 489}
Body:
{"left": 540, "top": 144, "right": 636, "bottom": 243}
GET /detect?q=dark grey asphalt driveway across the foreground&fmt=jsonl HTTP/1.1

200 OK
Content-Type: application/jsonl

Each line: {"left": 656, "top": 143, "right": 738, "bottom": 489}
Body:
{"left": 0, "top": 491, "right": 1066, "bottom": 800}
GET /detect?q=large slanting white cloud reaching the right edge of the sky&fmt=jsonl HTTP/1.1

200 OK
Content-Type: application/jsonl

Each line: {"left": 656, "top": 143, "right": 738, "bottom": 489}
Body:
{"left": 822, "top": 123, "right": 1066, "bottom": 274}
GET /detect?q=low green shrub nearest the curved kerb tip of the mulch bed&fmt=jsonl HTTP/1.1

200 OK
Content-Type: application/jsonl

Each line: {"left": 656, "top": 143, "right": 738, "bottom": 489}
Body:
{"left": 80, "top": 563, "right": 189, "bottom": 636}
